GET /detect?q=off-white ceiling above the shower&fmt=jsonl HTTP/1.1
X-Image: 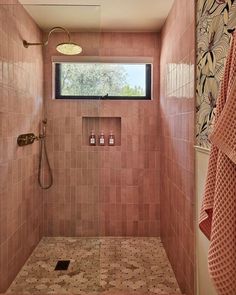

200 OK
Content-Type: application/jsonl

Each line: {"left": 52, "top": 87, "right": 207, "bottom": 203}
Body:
{"left": 19, "top": 0, "right": 174, "bottom": 32}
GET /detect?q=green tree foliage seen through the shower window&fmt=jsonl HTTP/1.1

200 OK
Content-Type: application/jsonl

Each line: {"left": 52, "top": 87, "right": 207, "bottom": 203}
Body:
{"left": 61, "top": 63, "right": 145, "bottom": 96}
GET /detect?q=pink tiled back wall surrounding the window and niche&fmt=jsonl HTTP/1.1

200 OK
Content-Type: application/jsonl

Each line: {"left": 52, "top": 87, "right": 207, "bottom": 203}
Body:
{"left": 44, "top": 33, "right": 160, "bottom": 236}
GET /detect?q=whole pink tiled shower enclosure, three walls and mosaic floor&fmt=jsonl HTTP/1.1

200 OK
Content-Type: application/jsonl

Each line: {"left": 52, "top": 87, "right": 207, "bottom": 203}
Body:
{"left": 0, "top": 0, "right": 195, "bottom": 295}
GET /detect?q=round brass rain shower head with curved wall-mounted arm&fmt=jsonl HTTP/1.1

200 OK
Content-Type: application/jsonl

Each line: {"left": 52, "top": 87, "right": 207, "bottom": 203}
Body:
{"left": 23, "top": 27, "right": 82, "bottom": 55}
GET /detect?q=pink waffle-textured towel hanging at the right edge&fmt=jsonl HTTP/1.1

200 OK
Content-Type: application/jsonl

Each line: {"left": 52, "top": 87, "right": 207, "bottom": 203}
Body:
{"left": 199, "top": 32, "right": 236, "bottom": 295}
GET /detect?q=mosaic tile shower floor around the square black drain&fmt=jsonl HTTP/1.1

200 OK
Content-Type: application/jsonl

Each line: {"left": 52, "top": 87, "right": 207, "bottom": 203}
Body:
{"left": 7, "top": 237, "right": 181, "bottom": 295}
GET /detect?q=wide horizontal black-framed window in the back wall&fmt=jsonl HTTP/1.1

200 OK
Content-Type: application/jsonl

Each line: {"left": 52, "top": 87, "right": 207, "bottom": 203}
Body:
{"left": 55, "top": 62, "right": 151, "bottom": 100}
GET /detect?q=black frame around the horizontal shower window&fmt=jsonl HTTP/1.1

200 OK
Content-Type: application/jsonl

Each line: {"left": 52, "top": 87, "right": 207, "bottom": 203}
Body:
{"left": 55, "top": 62, "right": 152, "bottom": 100}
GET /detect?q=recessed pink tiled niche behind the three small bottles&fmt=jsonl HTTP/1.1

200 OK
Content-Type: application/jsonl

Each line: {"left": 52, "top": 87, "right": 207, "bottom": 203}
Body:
{"left": 82, "top": 117, "right": 121, "bottom": 146}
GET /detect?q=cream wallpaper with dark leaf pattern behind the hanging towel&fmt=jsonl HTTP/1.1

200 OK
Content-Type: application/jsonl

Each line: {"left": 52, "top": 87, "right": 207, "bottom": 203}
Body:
{"left": 196, "top": 0, "right": 236, "bottom": 148}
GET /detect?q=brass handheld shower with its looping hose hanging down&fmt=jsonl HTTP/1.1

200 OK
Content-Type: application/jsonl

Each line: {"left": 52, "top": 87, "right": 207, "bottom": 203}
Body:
{"left": 38, "top": 120, "right": 53, "bottom": 189}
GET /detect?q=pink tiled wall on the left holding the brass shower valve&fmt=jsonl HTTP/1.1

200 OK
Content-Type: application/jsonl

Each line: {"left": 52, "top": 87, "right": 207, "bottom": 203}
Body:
{"left": 0, "top": 1, "right": 43, "bottom": 293}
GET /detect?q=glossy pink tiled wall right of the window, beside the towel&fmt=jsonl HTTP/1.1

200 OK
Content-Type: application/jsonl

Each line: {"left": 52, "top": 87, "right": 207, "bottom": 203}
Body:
{"left": 160, "top": 0, "right": 195, "bottom": 295}
